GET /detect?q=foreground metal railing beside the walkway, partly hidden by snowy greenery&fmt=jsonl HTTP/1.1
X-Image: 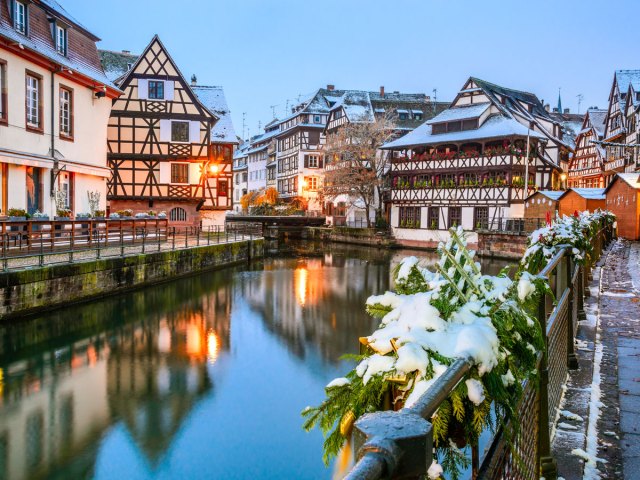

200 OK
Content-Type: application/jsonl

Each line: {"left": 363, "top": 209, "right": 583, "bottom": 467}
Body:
{"left": 346, "top": 224, "right": 612, "bottom": 480}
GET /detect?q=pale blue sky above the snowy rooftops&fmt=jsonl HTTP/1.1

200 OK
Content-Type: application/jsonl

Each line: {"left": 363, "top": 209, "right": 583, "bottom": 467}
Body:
{"left": 58, "top": 0, "right": 640, "bottom": 141}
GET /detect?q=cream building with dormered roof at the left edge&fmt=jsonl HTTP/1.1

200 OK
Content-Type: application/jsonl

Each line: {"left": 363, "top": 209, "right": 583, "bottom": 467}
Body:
{"left": 0, "top": 0, "right": 121, "bottom": 217}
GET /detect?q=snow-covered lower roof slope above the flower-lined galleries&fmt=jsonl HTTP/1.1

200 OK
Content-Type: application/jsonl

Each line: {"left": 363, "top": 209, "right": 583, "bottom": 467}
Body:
{"left": 381, "top": 115, "right": 546, "bottom": 149}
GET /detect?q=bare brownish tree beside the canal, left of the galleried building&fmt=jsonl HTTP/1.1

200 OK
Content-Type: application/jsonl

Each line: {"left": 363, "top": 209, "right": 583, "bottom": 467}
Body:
{"left": 321, "top": 116, "right": 395, "bottom": 227}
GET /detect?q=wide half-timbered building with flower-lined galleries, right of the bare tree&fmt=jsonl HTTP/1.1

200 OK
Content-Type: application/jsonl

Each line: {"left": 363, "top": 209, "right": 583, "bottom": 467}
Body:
{"left": 383, "top": 77, "right": 569, "bottom": 246}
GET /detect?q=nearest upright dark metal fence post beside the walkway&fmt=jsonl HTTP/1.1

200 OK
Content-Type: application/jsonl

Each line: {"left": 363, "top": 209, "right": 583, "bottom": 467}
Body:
{"left": 538, "top": 295, "right": 558, "bottom": 480}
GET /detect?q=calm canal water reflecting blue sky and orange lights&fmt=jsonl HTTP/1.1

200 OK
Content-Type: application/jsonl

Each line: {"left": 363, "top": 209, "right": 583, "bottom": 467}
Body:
{"left": 0, "top": 244, "right": 510, "bottom": 479}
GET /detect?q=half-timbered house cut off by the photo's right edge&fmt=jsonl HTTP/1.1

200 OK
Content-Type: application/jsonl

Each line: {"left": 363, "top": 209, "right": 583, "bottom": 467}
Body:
{"left": 604, "top": 70, "right": 640, "bottom": 185}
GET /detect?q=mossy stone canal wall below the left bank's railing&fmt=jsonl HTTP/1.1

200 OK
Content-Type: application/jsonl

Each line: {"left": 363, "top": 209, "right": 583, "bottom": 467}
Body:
{"left": 0, "top": 239, "right": 264, "bottom": 321}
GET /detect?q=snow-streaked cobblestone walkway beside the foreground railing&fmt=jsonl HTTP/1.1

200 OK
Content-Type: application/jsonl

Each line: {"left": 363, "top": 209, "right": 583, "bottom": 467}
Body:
{"left": 553, "top": 241, "right": 640, "bottom": 480}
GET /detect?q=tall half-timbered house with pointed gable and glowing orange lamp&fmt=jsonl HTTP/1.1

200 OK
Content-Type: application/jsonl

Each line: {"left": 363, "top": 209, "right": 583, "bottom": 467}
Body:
{"left": 108, "top": 36, "right": 233, "bottom": 225}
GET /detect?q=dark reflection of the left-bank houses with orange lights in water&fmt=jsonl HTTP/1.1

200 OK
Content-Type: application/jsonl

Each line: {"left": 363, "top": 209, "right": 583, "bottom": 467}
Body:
{"left": 0, "top": 270, "right": 231, "bottom": 479}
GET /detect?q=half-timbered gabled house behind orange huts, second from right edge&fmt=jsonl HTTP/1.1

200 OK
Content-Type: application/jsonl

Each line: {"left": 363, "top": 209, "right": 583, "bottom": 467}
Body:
{"left": 567, "top": 108, "right": 607, "bottom": 188}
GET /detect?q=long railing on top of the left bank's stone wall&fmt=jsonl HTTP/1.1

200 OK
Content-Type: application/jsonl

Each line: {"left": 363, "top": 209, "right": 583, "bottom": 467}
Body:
{"left": 0, "top": 220, "right": 262, "bottom": 271}
